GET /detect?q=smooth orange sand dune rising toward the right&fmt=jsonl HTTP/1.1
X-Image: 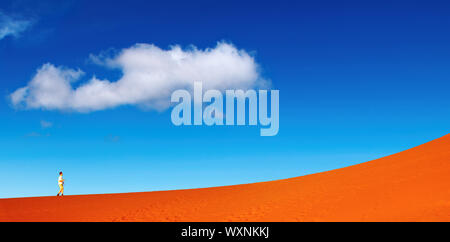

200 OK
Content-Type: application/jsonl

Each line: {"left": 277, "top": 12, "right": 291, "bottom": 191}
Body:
{"left": 0, "top": 135, "right": 450, "bottom": 221}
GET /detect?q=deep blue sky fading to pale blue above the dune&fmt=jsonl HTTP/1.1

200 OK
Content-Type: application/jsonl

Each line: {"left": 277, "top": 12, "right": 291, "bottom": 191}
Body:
{"left": 0, "top": 0, "right": 450, "bottom": 198}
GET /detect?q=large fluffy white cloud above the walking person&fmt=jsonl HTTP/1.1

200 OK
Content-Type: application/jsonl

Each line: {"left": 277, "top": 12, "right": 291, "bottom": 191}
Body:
{"left": 10, "top": 42, "right": 265, "bottom": 112}
